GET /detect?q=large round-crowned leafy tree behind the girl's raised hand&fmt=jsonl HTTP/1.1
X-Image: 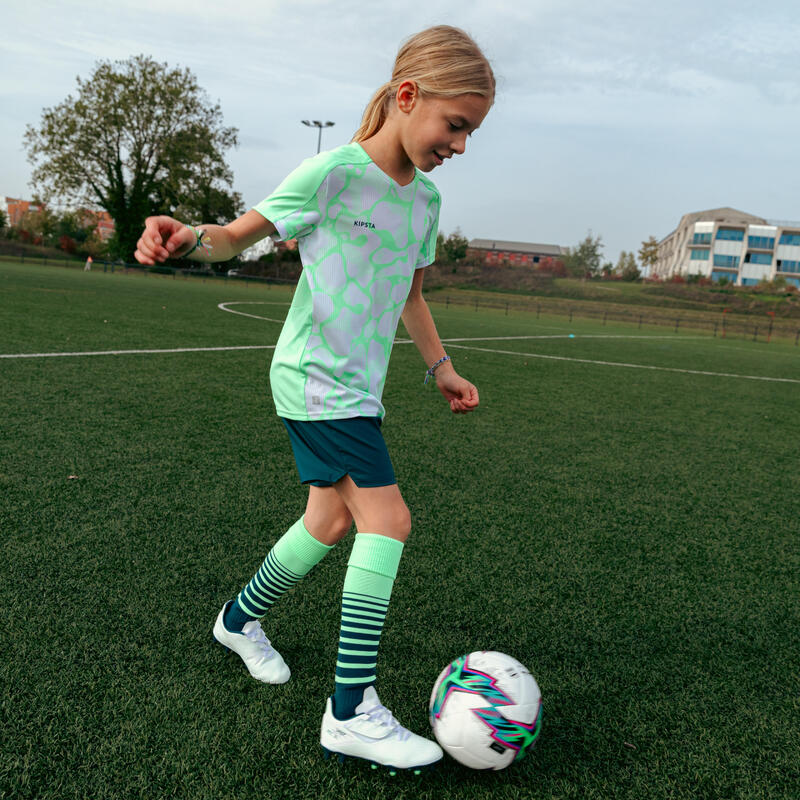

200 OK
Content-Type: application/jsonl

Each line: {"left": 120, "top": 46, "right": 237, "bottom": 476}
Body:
{"left": 25, "top": 55, "right": 241, "bottom": 258}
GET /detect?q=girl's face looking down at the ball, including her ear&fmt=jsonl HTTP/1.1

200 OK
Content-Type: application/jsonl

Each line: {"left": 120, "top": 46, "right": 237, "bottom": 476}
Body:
{"left": 397, "top": 84, "right": 491, "bottom": 172}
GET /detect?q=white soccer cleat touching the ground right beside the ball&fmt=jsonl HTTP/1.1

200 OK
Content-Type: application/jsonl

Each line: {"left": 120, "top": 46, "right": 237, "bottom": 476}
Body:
{"left": 320, "top": 686, "right": 442, "bottom": 774}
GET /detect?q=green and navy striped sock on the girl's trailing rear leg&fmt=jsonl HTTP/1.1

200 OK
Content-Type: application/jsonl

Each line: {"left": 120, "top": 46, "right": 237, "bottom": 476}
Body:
{"left": 223, "top": 517, "right": 333, "bottom": 633}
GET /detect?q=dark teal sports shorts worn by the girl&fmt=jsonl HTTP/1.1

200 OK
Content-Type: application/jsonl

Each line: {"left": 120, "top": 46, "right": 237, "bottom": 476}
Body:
{"left": 281, "top": 417, "right": 397, "bottom": 488}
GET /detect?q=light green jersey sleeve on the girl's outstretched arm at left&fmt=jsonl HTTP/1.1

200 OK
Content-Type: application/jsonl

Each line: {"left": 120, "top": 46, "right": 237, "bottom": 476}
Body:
{"left": 253, "top": 153, "right": 330, "bottom": 241}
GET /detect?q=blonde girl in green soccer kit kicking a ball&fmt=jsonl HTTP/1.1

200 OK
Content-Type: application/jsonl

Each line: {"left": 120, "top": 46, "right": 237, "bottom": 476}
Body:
{"left": 136, "top": 26, "right": 495, "bottom": 770}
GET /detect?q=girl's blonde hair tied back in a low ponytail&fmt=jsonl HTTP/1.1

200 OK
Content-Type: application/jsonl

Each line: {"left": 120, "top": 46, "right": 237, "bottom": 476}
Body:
{"left": 352, "top": 25, "right": 495, "bottom": 142}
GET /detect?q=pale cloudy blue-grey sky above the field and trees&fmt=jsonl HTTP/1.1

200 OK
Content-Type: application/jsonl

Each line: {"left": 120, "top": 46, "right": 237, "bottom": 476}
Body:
{"left": 0, "top": 0, "right": 800, "bottom": 263}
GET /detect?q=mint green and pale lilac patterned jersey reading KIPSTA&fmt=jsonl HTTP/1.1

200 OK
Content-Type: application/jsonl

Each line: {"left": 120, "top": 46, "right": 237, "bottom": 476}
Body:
{"left": 255, "top": 144, "right": 440, "bottom": 420}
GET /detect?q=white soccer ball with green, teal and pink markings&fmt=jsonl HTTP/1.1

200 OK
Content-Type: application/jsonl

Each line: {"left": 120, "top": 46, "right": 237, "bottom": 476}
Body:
{"left": 428, "top": 650, "right": 542, "bottom": 769}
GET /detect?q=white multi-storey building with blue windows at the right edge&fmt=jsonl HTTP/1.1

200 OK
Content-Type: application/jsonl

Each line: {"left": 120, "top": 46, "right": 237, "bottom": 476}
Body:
{"left": 650, "top": 208, "right": 800, "bottom": 287}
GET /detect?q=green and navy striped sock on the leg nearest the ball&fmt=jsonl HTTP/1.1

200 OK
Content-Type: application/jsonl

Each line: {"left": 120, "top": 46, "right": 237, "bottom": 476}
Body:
{"left": 333, "top": 533, "right": 403, "bottom": 719}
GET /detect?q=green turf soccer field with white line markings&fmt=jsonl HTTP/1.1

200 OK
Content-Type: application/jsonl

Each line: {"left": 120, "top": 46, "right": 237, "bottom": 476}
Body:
{"left": 0, "top": 263, "right": 800, "bottom": 800}
